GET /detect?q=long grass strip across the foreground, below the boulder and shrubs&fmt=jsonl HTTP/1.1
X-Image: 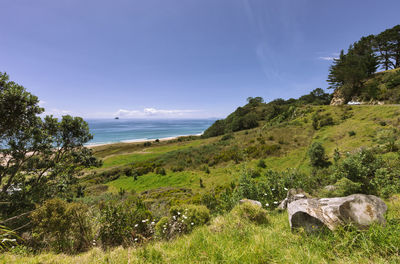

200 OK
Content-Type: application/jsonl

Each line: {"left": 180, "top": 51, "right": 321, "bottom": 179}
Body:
{"left": 0, "top": 196, "right": 400, "bottom": 264}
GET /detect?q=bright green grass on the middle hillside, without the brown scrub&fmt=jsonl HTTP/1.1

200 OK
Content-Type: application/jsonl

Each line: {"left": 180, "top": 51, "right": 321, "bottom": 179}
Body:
{"left": 99, "top": 105, "right": 400, "bottom": 192}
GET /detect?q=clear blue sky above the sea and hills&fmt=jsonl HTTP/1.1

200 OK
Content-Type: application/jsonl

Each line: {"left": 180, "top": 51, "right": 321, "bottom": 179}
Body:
{"left": 0, "top": 0, "right": 400, "bottom": 118}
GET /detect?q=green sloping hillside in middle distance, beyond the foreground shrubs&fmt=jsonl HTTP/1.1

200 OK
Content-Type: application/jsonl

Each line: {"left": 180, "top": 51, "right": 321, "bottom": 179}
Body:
{"left": 82, "top": 105, "right": 400, "bottom": 195}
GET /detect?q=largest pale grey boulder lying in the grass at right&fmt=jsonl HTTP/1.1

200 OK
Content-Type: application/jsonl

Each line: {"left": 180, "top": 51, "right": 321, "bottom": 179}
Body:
{"left": 287, "top": 194, "right": 387, "bottom": 232}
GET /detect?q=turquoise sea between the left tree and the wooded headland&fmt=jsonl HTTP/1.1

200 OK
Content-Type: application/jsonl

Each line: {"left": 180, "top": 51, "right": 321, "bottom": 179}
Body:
{"left": 86, "top": 119, "right": 215, "bottom": 145}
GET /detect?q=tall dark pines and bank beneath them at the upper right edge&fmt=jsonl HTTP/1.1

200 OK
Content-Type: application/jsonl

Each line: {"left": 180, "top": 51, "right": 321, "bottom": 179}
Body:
{"left": 328, "top": 25, "right": 400, "bottom": 103}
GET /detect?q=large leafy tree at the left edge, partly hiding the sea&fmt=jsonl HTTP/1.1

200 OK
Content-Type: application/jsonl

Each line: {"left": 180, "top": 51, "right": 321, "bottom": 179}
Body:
{"left": 0, "top": 72, "right": 101, "bottom": 217}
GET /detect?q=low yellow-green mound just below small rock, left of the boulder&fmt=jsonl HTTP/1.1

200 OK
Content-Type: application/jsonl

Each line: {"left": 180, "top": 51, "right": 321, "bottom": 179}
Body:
{"left": 231, "top": 203, "right": 268, "bottom": 225}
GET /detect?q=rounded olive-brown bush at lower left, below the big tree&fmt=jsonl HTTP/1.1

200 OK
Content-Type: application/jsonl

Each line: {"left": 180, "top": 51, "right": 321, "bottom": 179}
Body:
{"left": 31, "top": 198, "right": 93, "bottom": 253}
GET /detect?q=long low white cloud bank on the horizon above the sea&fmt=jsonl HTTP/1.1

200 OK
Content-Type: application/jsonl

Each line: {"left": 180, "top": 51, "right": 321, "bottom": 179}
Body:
{"left": 115, "top": 107, "right": 199, "bottom": 118}
